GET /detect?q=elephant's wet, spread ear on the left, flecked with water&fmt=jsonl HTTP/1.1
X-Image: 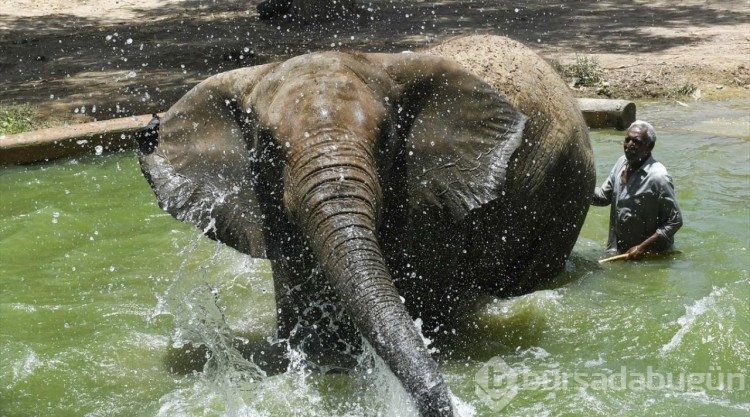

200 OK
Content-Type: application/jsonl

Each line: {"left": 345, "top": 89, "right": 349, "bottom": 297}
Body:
{"left": 140, "top": 65, "right": 273, "bottom": 257}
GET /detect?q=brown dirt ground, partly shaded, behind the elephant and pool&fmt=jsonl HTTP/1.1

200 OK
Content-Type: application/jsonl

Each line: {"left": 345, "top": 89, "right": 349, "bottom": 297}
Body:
{"left": 0, "top": 0, "right": 750, "bottom": 127}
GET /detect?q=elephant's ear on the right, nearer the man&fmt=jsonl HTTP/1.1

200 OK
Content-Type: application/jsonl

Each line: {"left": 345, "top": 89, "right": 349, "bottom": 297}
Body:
{"left": 369, "top": 54, "right": 527, "bottom": 221}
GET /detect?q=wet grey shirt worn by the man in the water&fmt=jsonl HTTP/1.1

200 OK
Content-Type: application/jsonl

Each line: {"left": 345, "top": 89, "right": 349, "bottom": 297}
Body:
{"left": 592, "top": 156, "right": 682, "bottom": 252}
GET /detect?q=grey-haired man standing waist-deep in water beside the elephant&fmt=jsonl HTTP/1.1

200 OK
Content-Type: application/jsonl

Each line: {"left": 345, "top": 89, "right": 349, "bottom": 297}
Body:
{"left": 592, "top": 120, "right": 682, "bottom": 259}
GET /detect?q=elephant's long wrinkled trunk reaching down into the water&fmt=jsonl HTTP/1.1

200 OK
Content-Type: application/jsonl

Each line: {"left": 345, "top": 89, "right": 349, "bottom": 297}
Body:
{"left": 285, "top": 135, "right": 453, "bottom": 417}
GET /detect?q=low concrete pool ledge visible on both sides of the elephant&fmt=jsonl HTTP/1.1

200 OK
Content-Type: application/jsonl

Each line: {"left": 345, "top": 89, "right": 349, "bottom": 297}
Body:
{"left": 0, "top": 98, "right": 635, "bottom": 166}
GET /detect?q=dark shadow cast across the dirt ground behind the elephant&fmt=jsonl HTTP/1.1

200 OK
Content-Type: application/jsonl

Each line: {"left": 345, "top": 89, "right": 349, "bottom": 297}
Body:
{"left": 0, "top": 0, "right": 746, "bottom": 120}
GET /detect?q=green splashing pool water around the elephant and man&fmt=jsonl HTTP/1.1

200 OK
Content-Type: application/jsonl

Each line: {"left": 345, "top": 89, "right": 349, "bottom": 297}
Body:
{"left": 0, "top": 100, "right": 750, "bottom": 416}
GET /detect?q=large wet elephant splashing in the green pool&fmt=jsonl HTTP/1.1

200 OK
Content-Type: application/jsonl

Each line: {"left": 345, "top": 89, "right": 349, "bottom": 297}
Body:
{"left": 139, "top": 36, "right": 595, "bottom": 416}
